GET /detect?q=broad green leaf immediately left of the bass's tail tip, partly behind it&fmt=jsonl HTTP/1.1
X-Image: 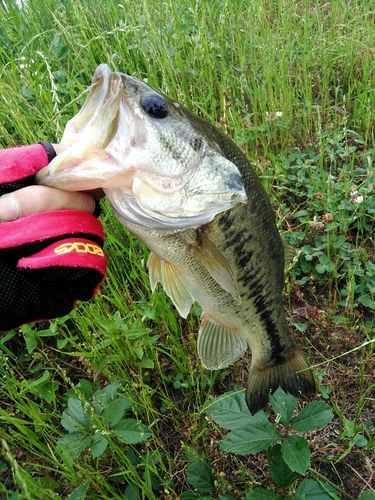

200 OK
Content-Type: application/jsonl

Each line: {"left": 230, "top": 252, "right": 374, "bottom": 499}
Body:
{"left": 206, "top": 392, "right": 254, "bottom": 430}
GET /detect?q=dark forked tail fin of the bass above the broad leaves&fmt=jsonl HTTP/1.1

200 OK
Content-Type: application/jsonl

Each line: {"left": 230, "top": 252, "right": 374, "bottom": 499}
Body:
{"left": 246, "top": 347, "right": 316, "bottom": 415}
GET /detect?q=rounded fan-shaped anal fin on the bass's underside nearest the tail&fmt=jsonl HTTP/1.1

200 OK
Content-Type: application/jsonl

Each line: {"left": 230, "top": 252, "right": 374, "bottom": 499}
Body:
{"left": 197, "top": 315, "right": 247, "bottom": 370}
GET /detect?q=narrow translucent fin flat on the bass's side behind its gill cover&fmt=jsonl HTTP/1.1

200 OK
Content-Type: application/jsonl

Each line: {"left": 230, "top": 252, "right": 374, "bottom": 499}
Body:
{"left": 191, "top": 230, "right": 241, "bottom": 304}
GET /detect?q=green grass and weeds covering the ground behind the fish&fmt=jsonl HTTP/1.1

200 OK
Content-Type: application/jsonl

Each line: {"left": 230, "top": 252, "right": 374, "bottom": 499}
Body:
{"left": 0, "top": 0, "right": 375, "bottom": 500}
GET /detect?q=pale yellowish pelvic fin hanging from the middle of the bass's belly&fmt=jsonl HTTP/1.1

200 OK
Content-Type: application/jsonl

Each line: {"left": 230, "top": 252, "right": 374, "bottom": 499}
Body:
{"left": 147, "top": 252, "right": 194, "bottom": 318}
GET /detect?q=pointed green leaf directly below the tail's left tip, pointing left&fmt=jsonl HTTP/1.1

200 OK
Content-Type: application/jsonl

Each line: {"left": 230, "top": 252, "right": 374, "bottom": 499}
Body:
{"left": 220, "top": 417, "right": 281, "bottom": 455}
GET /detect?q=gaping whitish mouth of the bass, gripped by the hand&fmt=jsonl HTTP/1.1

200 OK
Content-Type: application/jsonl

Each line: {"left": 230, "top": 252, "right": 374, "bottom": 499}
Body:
{"left": 36, "top": 64, "right": 129, "bottom": 191}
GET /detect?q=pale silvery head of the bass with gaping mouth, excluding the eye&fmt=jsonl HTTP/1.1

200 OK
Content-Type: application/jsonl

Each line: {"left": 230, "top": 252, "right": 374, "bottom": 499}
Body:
{"left": 36, "top": 64, "right": 247, "bottom": 229}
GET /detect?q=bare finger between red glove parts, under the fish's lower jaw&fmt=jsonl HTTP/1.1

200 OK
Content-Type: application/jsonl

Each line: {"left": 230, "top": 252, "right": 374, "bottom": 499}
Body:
{"left": 0, "top": 186, "right": 95, "bottom": 222}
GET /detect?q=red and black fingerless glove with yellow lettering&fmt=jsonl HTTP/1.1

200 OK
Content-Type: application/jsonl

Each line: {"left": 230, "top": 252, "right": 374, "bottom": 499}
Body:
{"left": 0, "top": 142, "right": 106, "bottom": 330}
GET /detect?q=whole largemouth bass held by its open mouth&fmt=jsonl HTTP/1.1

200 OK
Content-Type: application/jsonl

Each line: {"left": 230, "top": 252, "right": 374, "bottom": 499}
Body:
{"left": 37, "top": 64, "right": 316, "bottom": 414}
